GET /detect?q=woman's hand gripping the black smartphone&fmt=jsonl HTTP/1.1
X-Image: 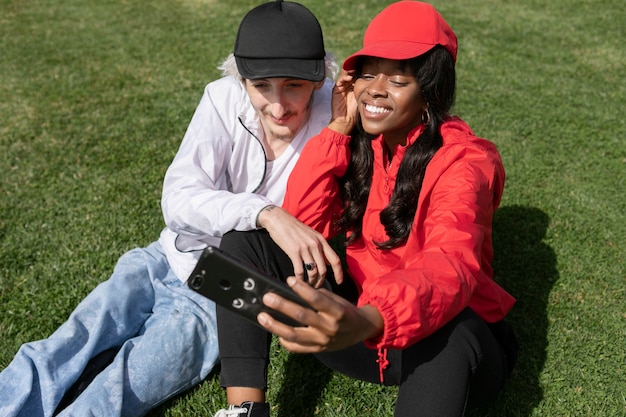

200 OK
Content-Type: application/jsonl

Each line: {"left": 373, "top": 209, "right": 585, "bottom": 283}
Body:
{"left": 257, "top": 277, "right": 383, "bottom": 353}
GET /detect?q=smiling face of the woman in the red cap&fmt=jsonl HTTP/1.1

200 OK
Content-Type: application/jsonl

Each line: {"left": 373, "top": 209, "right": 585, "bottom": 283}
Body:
{"left": 354, "top": 57, "right": 426, "bottom": 149}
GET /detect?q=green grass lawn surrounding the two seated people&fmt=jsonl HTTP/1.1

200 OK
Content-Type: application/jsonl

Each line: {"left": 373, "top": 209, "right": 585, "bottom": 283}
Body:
{"left": 0, "top": 0, "right": 626, "bottom": 417}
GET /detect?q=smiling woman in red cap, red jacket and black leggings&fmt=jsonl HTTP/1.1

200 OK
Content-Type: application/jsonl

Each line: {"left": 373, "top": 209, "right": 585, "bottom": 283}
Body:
{"left": 218, "top": 1, "right": 517, "bottom": 416}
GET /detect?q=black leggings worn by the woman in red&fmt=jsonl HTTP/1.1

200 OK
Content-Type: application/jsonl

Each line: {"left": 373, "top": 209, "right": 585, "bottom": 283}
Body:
{"left": 217, "top": 231, "right": 516, "bottom": 417}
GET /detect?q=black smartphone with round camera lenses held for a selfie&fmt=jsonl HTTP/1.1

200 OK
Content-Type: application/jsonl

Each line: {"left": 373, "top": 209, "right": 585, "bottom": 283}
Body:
{"left": 187, "top": 246, "right": 312, "bottom": 327}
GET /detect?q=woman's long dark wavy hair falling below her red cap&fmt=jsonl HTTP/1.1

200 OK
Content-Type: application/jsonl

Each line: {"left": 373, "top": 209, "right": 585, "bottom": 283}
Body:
{"left": 337, "top": 46, "right": 456, "bottom": 249}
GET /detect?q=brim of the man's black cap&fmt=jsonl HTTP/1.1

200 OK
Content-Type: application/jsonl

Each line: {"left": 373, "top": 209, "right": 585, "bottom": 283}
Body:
{"left": 235, "top": 56, "right": 326, "bottom": 81}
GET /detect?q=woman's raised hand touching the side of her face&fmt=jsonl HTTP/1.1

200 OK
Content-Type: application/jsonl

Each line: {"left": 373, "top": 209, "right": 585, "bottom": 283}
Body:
{"left": 328, "top": 70, "right": 358, "bottom": 135}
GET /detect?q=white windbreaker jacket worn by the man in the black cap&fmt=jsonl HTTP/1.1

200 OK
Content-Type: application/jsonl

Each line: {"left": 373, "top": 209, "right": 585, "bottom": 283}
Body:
{"left": 159, "top": 77, "right": 333, "bottom": 281}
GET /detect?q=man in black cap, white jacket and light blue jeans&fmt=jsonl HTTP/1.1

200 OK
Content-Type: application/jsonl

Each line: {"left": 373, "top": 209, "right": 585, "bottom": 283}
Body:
{"left": 0, "top": 1, "right": 337, "bottom": 417}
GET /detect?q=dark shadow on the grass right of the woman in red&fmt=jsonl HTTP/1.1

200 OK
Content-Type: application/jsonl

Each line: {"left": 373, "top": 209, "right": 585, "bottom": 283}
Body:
{"left": 469, "top": 206, "right": 559, "bottom": 417}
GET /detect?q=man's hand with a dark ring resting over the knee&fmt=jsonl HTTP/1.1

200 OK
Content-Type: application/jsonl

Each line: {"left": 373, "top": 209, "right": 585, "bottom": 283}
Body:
{"left": 257, "top": 206, "right": 343, "bottom": 288}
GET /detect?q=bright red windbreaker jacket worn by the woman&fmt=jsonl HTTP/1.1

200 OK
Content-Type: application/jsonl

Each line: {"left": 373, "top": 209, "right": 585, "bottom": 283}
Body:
{"left": 283, "top": 117, "right": 515, "bottom": 349}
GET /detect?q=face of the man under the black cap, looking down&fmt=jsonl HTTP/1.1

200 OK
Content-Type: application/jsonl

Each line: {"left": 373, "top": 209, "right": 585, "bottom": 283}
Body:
{"left": 245, "top": 78, "right": 322, "bottom": 141}
